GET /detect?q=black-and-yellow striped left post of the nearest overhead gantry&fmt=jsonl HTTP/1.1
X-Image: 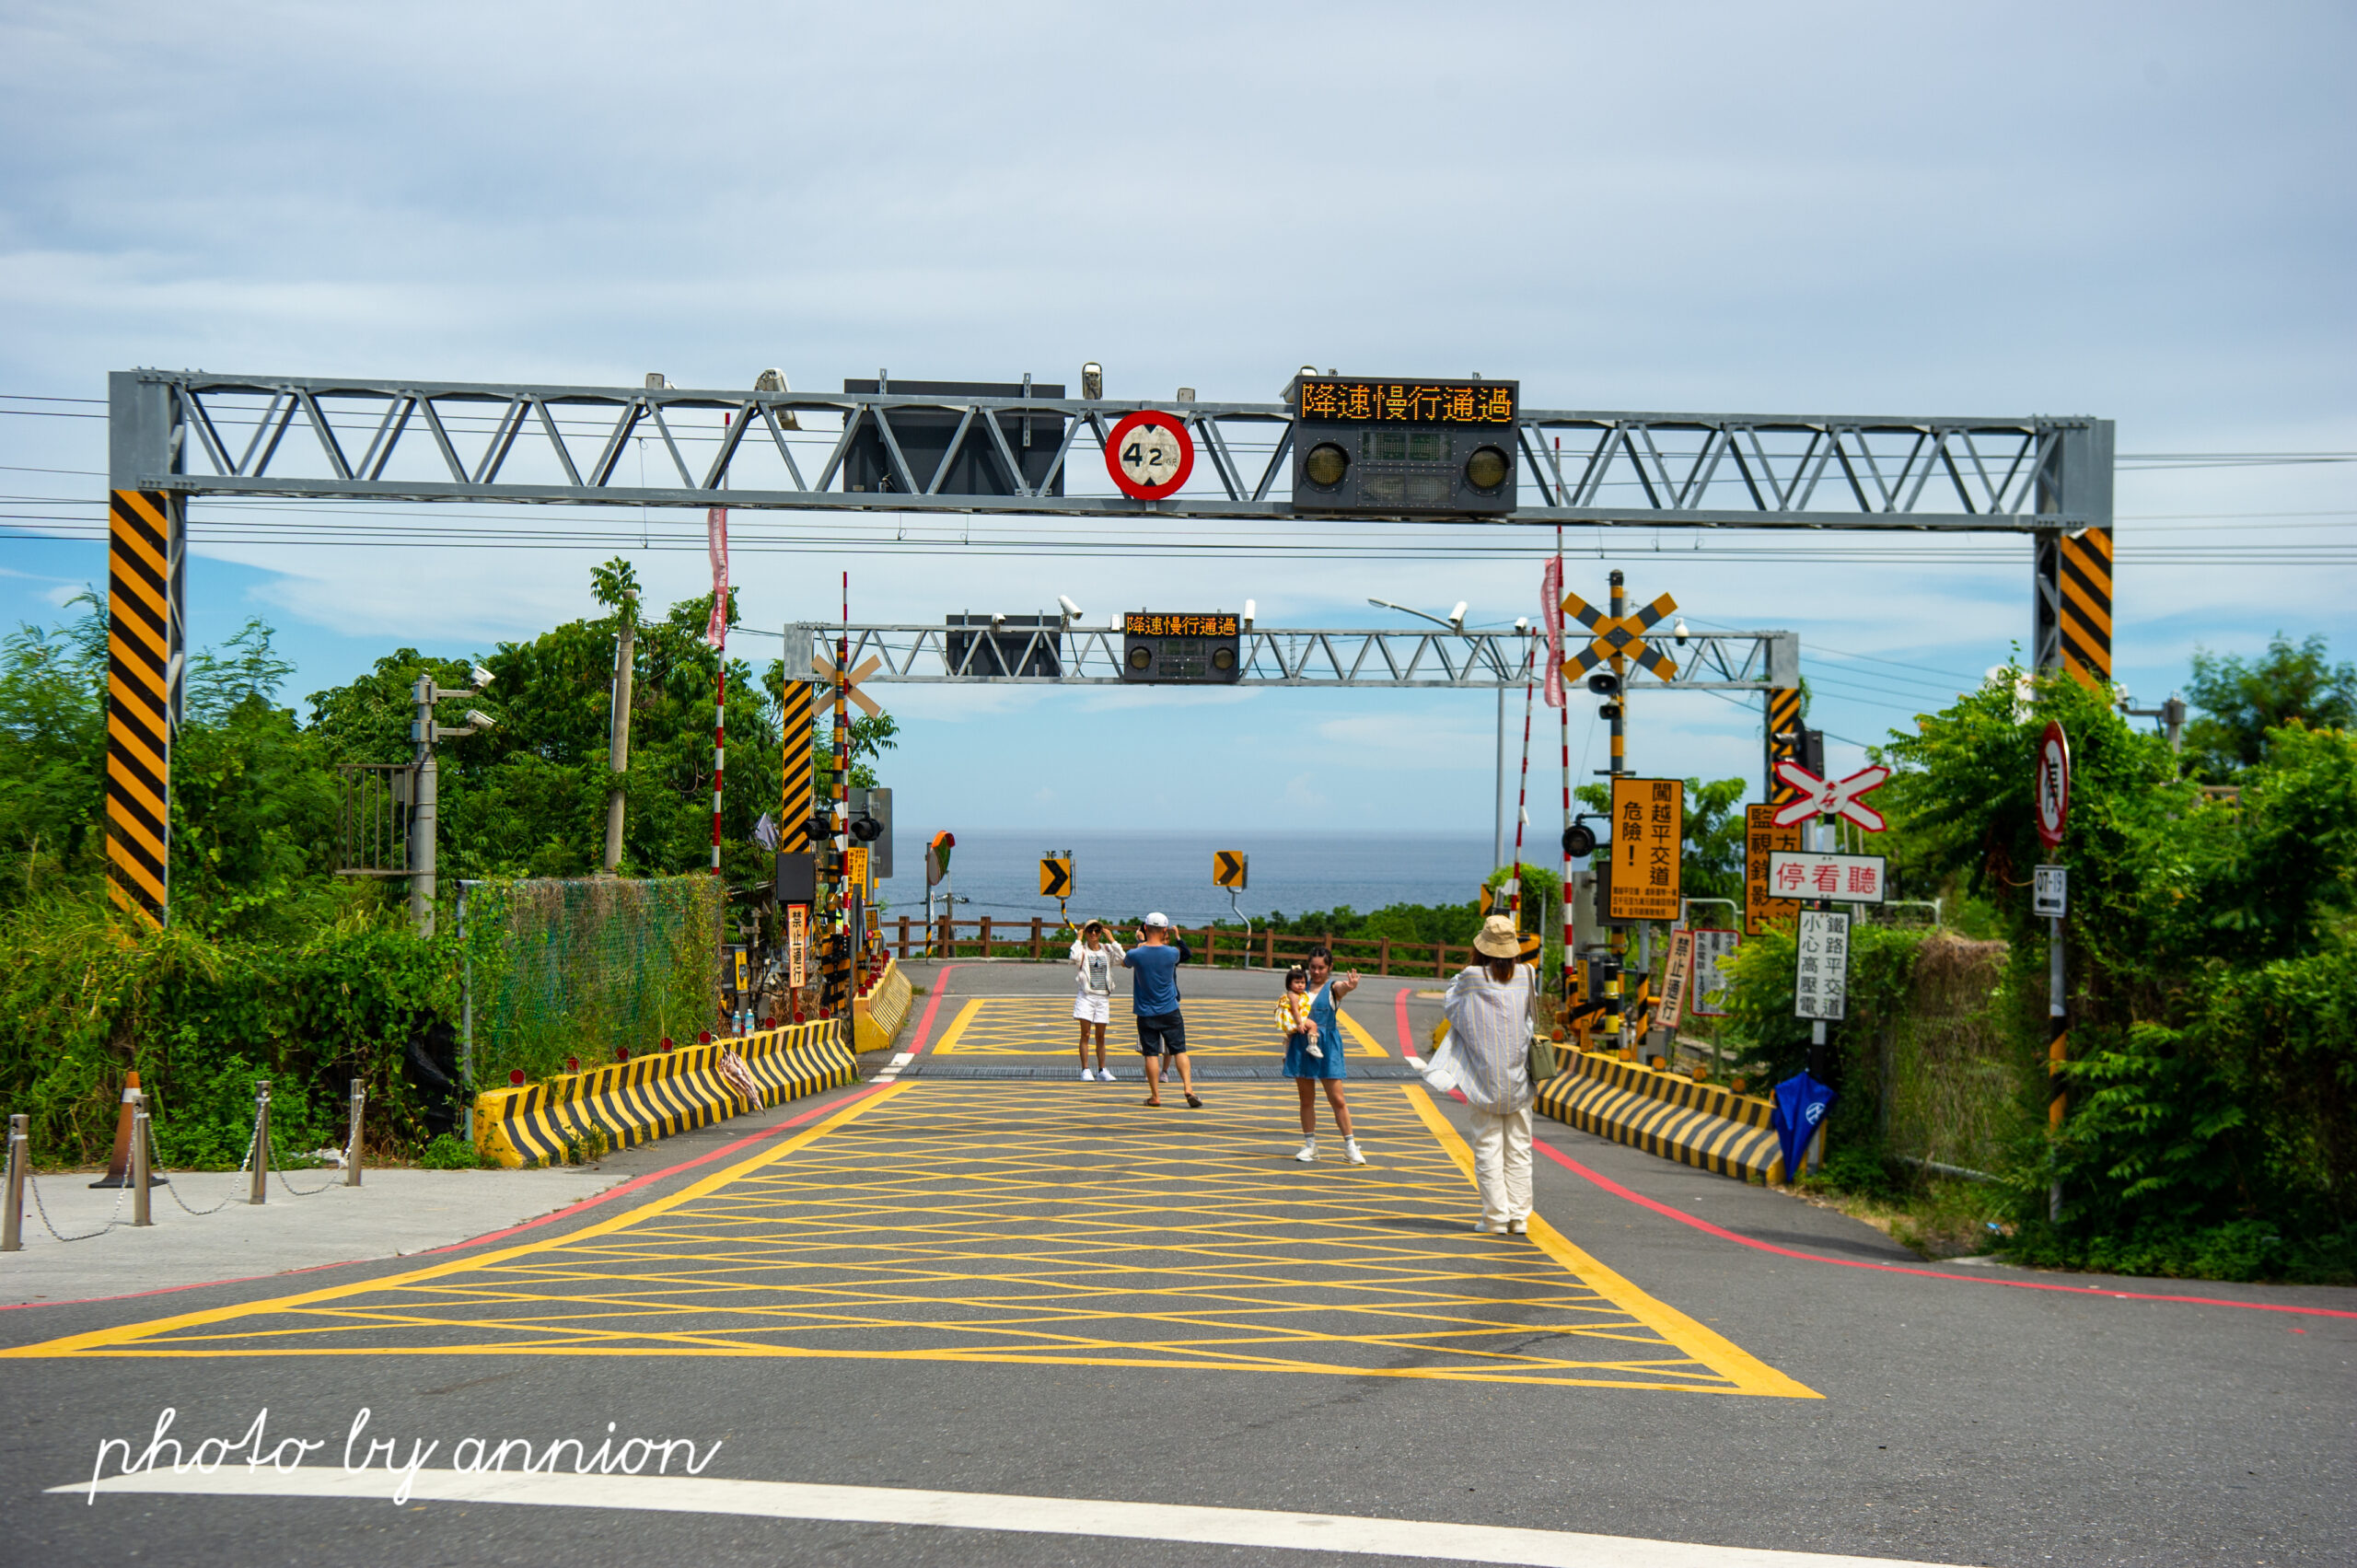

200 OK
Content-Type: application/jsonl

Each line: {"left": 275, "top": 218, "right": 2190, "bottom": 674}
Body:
{"left": 106, "top": 491, "right": 186, "bottom": 924}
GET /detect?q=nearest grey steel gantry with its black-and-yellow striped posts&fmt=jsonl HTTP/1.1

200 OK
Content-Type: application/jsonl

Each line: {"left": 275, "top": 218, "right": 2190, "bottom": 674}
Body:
{"left": 106, "top": 370, "right": 2112, "bottom": 920}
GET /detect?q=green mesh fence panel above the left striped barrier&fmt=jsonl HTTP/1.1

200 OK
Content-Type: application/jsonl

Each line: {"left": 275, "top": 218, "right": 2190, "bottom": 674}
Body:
{"left": 467, "top": 877, "right": 726, "bottom": 1085}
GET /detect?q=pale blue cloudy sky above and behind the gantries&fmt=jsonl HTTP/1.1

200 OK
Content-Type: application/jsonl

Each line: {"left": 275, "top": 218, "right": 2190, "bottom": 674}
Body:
{"left": 0, "top": 0, "right": 2357, "bottom": 858}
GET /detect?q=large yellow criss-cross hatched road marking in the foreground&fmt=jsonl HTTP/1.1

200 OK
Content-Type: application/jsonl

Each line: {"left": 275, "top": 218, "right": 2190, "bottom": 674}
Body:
{"left": 0, "top": 1080, "right": 1815, "bottom": 1399}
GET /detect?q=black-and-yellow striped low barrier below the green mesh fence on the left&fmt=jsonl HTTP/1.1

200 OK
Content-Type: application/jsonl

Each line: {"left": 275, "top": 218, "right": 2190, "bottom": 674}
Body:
{"left": 474, "top": 1021, "right": 858, "bottom": 1169}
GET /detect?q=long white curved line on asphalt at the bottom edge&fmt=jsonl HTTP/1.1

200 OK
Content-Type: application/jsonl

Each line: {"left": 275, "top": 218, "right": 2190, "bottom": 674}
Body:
{"left": 50, "top": 1462, "right": 1970, "bottom": 1568}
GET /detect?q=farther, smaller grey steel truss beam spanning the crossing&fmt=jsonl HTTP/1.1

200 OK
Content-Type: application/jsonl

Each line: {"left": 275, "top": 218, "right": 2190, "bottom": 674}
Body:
{"left": 784, "top": 622, "right": 1801, "bottom": 691}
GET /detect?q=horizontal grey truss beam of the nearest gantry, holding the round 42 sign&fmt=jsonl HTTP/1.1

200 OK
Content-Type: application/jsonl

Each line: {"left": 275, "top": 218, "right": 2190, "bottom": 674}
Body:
{"left": 110, "top": 370, "right": 2112, "bottom": 533}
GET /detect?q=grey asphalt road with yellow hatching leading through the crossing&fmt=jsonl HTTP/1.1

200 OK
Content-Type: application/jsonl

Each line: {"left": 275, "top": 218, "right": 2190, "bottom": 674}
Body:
{"left": 0, "top": 964, "right": 2357, "bottom": 1568}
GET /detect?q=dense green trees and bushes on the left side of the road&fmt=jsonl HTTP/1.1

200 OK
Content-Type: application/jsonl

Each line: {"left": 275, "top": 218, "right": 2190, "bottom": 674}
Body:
{"left": 0, "top": 561, "right": 893, "bottom": 1165}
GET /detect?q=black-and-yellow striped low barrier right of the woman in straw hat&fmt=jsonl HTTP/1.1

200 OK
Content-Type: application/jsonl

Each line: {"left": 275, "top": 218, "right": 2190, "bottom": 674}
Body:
{"left": 1539, "top": 1051, "right": 1784, "bottom": 1184}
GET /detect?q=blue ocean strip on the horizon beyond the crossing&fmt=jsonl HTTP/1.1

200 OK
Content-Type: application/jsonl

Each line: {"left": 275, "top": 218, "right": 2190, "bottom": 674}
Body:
{"left": 877, "top": 828, "right": 1490, "bottom": 924}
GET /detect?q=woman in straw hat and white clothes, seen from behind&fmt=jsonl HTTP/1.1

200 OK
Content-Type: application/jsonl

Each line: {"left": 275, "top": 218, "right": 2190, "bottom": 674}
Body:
{"left": 1433, "top": 915, "right": 1532, "bottom": 1236}
